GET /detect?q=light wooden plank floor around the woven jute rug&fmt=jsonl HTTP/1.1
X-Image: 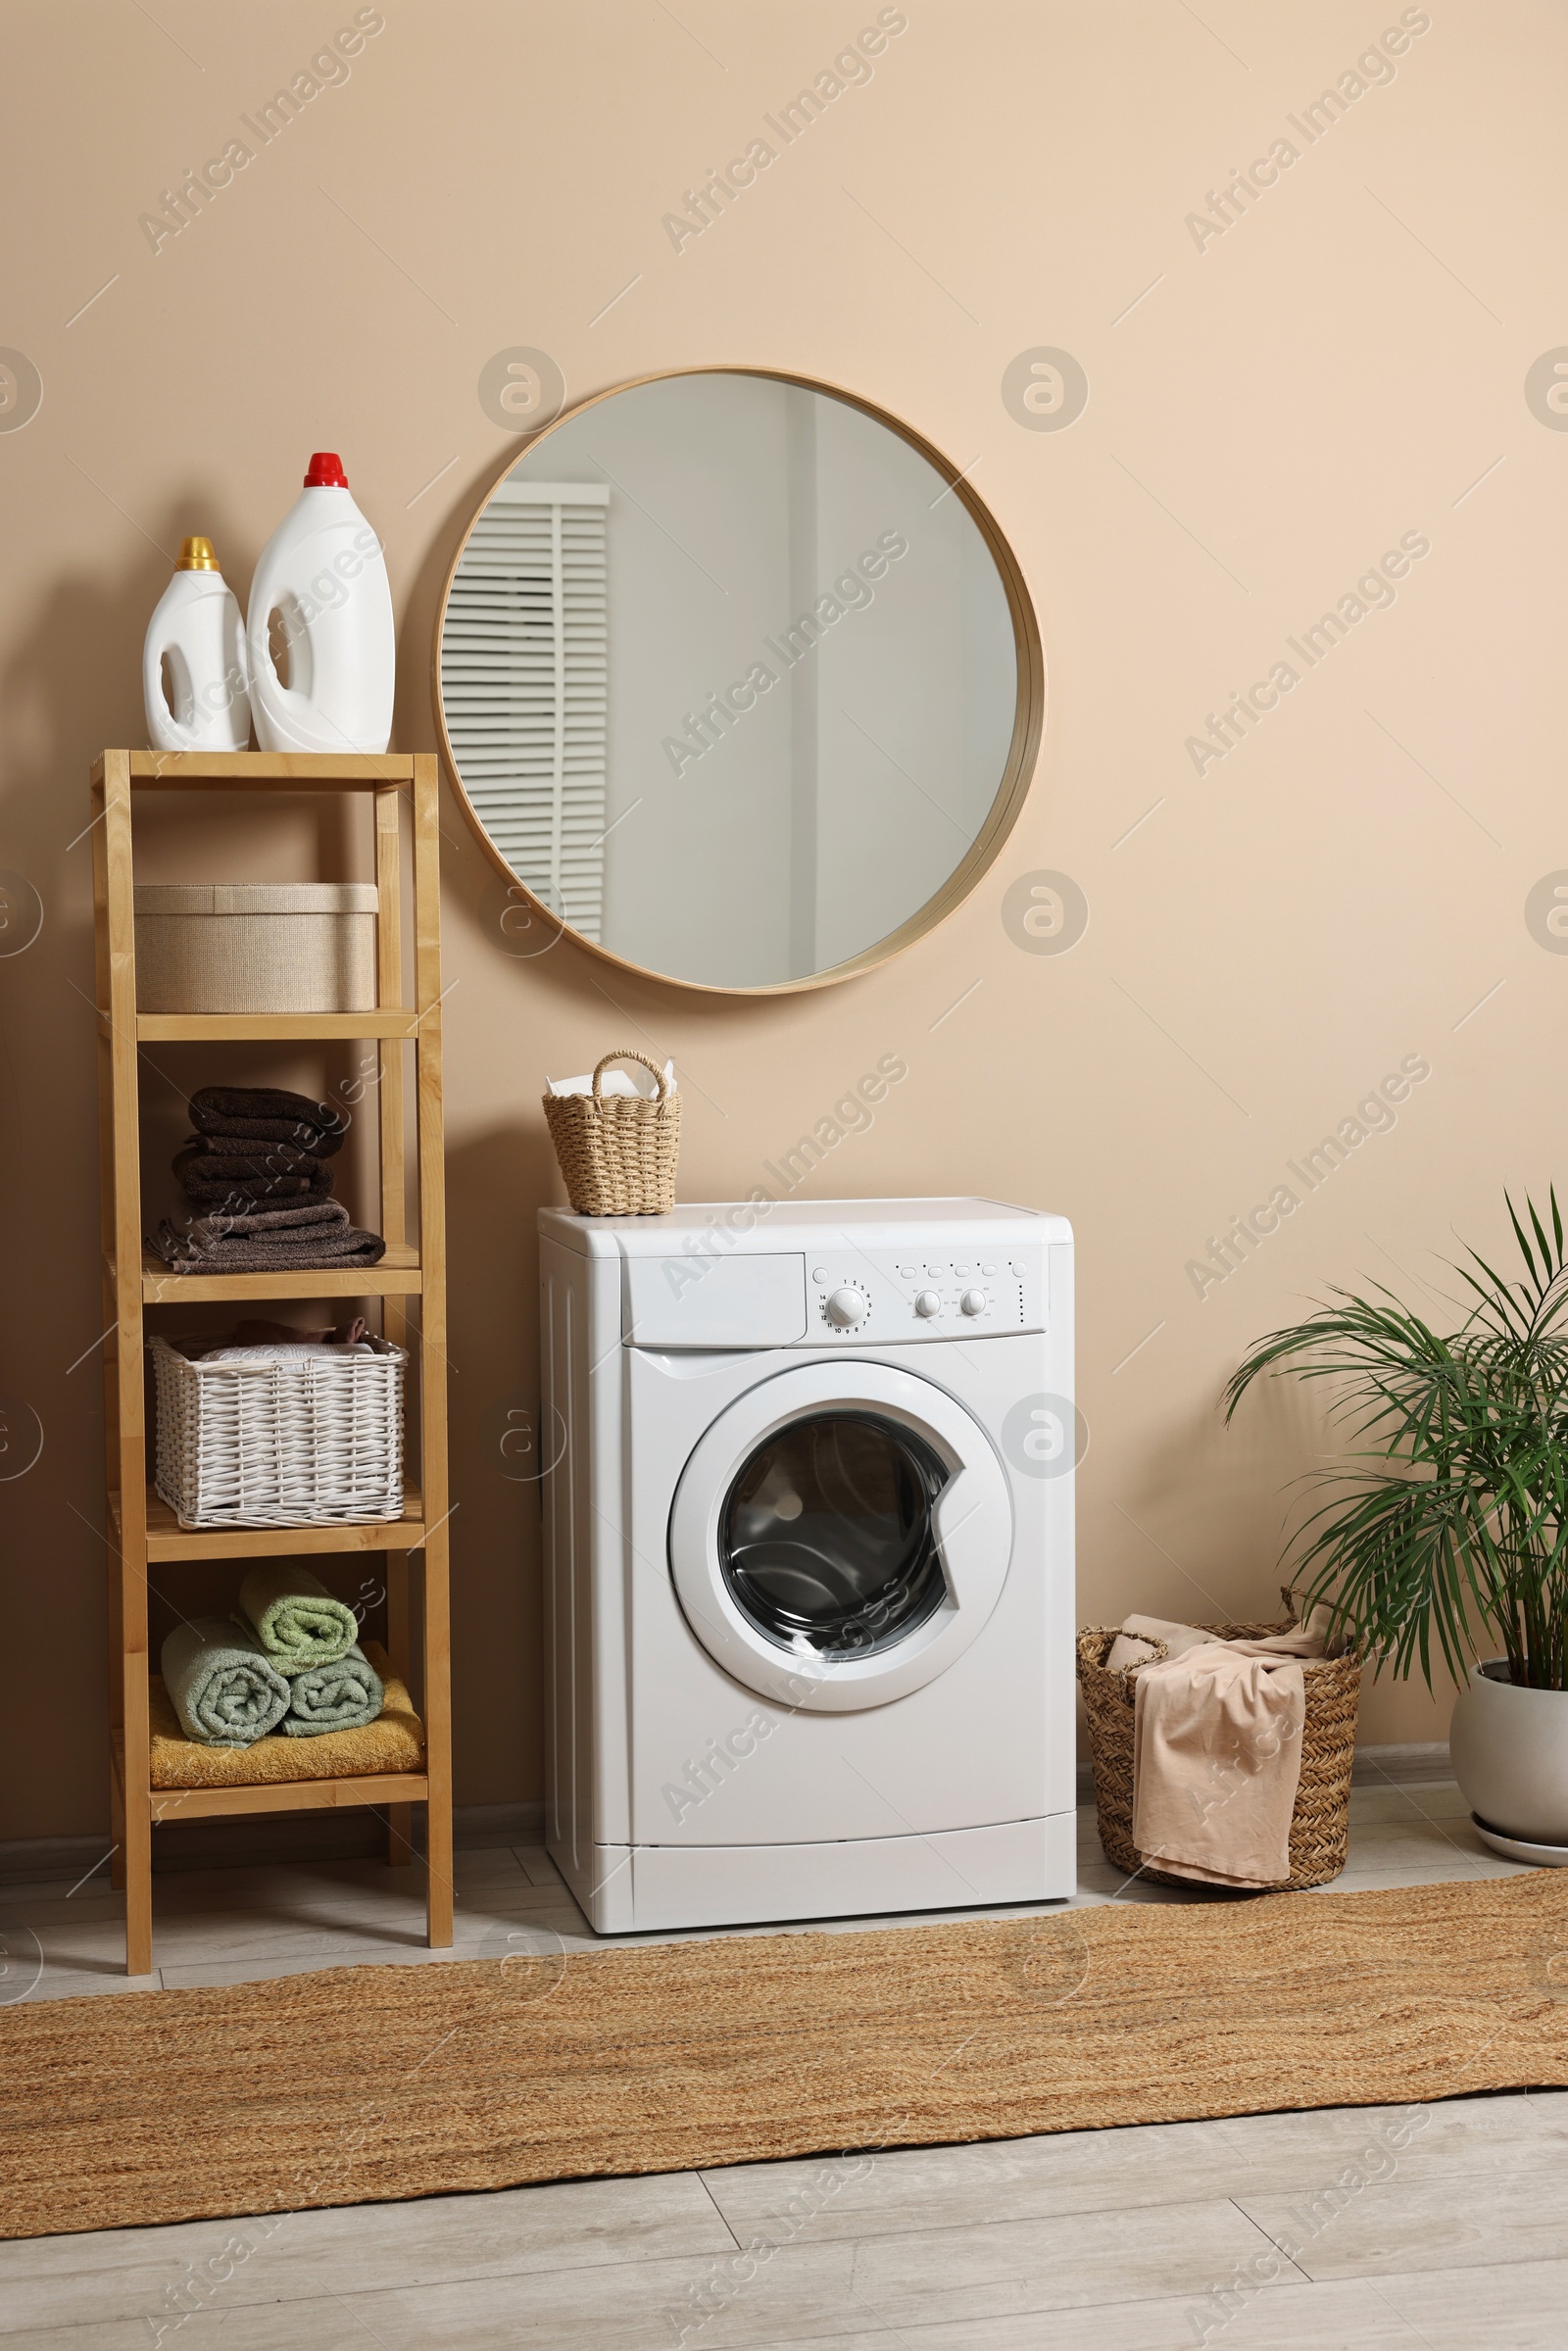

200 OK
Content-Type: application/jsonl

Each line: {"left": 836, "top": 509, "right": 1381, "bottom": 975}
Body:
{"left": 0, "top": 1785, "right": 1568, "bottom": 2351}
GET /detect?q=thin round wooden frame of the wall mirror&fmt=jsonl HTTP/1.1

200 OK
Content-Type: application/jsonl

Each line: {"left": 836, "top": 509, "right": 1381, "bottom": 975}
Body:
{"left": 430, "top": 362, "right": 1046, "bottom": 997}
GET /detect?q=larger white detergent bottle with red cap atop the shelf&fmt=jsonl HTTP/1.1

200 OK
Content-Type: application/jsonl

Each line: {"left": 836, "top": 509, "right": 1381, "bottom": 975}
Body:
{"left": 247, "top": 449, "right": 395, "bottom": 753}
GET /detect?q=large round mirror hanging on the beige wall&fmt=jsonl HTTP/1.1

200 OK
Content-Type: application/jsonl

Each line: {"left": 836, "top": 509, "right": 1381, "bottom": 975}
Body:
{"left": 435, "top": 369, "right": 1044, "bottom": 990}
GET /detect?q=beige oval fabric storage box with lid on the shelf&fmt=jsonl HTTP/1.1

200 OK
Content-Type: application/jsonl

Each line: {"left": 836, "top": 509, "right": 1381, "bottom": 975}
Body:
{"left": 136, "top": 882, "right": 376, "bottom": 1013}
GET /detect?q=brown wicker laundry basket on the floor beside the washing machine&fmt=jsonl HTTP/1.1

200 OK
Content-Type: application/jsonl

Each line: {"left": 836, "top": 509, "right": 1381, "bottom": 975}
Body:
{"left": 1079, "top": 1592, "right": 1361, "bottom": 1892}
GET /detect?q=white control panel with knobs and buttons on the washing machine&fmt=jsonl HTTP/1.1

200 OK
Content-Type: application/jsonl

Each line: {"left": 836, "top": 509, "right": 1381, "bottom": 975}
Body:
{"left": 807, "top": 1249, "right": 1046, "bottom": 1345}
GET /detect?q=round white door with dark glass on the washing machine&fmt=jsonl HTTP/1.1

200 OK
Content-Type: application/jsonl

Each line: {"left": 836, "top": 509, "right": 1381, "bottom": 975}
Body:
{"left": 670, "top": 1361, "right": 1013, "bottom": 1711}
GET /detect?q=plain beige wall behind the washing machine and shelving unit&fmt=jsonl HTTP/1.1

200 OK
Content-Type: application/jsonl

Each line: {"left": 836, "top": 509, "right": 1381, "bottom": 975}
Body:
{"left": 0, "top": 0, "right": 1568, "bottom": 1837}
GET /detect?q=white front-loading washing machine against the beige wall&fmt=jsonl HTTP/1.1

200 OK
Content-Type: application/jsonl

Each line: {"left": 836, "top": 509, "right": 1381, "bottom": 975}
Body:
{"left": 538, "top": 1199, "right": 1077, "bottom": 1933}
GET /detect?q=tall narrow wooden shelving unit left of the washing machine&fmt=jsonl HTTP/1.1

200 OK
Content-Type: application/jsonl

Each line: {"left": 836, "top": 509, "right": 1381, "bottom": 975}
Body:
{"left": 92, "top": 750, "right": 452, "bottom": 1975}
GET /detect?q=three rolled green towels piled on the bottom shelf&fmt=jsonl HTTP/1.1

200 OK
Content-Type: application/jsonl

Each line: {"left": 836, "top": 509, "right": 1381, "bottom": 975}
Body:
{"left": 163, "top": 1559, "right": 385, "bottom": 1746}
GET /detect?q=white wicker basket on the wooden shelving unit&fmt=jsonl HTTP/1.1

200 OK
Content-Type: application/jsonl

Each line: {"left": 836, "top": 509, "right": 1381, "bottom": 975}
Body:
{"left": 151, "top": 1338, "right": 409, "bottom": 1526}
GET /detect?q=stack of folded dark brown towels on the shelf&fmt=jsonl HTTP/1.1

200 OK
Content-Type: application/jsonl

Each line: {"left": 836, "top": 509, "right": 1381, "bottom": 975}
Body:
{"left": 148, "top": 1086, "right": 385, "bottom": 1274}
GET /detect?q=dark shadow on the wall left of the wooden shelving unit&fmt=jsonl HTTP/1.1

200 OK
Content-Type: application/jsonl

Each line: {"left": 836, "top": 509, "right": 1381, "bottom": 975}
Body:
{"left": 0, "top": 505, "right": 248, "bottom": 1837}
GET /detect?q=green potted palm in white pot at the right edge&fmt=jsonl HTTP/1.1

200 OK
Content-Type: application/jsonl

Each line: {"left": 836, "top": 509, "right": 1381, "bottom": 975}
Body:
{"left": 1225, "top": 1190, "right": 1568, "bottom": 1860}
